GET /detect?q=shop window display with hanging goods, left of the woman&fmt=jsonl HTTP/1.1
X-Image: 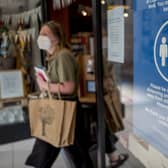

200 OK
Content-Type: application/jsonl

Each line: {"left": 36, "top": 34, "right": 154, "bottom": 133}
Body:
{"left": 0, "top": 0, "right": 42, "bottom": 143}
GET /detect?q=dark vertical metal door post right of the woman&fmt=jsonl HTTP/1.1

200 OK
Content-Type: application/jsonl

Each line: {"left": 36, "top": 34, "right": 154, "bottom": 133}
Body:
{"left": 92, "top": 0, "right": 105, "bottom": 168}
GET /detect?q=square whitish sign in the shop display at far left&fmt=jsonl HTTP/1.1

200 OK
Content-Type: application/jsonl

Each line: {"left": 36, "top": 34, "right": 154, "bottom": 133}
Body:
{"left": 0, "top": 70, "right": 24, "bottom": 99}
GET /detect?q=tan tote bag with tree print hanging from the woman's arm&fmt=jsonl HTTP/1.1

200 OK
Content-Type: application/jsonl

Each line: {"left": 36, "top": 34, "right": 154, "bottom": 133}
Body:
{"left": 29, "top": 90, "right": 76, "bottom": 147}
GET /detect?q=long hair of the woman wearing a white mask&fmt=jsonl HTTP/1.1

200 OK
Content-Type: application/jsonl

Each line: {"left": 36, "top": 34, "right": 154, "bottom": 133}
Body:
{"left": 43, "top": 20, "right": 70, "bottom": 48}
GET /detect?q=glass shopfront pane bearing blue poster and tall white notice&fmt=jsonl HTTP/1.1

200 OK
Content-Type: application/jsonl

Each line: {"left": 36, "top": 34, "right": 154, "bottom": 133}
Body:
{"left": 103, "top": 0, "right": 168, "bottom": 167}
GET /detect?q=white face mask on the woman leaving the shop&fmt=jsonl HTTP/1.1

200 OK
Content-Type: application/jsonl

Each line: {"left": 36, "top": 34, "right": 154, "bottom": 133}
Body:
{"left": 37, "top": 35, "right": 52, "bottom": 51}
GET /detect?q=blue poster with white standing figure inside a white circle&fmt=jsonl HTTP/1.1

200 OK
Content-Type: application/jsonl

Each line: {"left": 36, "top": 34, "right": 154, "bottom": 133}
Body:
{"left": 133, "top": 0, "right": 168, "bottom": 156}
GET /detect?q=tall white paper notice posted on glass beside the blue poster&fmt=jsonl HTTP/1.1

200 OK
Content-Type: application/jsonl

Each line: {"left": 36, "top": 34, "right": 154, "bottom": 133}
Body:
{"left": 107, "top": 7, "right": 124, "bottom": 63}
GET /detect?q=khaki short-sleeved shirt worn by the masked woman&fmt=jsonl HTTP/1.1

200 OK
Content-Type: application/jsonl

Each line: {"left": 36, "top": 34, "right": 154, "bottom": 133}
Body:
{"left": 48, "top": 49, "right": 78, "bottom": 97}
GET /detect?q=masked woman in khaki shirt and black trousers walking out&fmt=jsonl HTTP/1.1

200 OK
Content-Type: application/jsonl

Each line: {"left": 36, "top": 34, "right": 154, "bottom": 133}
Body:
{"left": 26, "top": 21, "right": 92, "bottom": 168}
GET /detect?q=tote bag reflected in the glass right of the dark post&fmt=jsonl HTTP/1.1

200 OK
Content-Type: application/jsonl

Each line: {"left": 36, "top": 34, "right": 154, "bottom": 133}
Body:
{"left": 104, "top": 87, "right": 124, "bottom": 133}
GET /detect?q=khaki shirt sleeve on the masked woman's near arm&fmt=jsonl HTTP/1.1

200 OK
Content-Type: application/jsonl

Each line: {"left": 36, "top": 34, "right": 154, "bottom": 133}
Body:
{"left": 57, "top": 52, "right": 76, "bottom": 83}
